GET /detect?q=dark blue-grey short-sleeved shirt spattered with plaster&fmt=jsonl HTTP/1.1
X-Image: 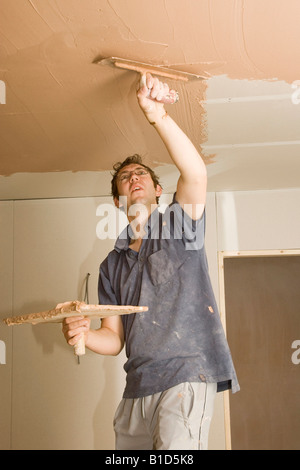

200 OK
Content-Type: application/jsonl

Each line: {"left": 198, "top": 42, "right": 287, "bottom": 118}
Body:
{"left": 98, "top": 197, "right": 239, "bottom": 398}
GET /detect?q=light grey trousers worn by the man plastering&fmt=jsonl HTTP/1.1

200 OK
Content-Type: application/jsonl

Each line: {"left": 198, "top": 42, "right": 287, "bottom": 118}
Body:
{"left": 114, "top": 382, "right": 217, "bottom": 450}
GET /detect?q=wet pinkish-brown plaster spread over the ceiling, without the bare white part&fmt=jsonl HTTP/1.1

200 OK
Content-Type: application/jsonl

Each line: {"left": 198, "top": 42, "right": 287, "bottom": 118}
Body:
{"left": 0, "top": 0, "right": 300, "bottom": 175}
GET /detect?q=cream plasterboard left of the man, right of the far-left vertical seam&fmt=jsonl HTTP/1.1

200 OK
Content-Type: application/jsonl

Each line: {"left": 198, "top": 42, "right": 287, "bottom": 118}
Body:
{"left": 12, "top": 198, "right": 124, "bottom": 449}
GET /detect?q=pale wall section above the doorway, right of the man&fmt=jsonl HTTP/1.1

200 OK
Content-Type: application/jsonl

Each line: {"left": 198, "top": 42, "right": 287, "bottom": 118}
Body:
{"left": 217, "top": 189, "right": 300, "bottom": 251}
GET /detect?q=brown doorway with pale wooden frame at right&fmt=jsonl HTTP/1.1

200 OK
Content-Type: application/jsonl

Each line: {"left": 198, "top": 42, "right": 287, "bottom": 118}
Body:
{"left": 219, "top": 250, "right": 300, "bottom": 450}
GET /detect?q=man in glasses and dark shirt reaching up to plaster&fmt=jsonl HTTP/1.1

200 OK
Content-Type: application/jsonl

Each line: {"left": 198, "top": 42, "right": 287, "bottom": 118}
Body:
{"left": 63, "top": 74, "right": 239, "bottom": 450}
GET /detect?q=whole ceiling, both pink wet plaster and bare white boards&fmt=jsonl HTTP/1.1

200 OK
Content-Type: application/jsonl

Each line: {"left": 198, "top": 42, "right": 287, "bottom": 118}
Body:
{"left": 0, "top": 0, "right": 300, "bottom": 198}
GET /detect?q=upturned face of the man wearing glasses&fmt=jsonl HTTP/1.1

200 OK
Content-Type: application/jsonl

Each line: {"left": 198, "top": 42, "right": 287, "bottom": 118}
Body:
{"left": 114, "top": 163, "right": 162, "bottom": 208}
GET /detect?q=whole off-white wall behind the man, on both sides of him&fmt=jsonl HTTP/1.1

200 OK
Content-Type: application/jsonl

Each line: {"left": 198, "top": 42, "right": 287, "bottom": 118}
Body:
{"left": 0, "top": 189, "right": 300, "bottom": 449}
